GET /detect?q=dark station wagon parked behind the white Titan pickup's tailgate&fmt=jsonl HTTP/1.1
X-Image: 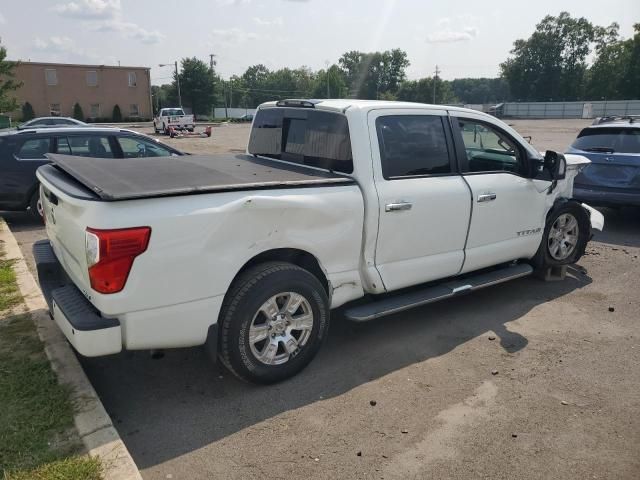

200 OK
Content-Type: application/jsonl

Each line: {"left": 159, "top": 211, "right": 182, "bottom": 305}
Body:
{"left": 0, "top": 127, "right": 184, "bottom": 217}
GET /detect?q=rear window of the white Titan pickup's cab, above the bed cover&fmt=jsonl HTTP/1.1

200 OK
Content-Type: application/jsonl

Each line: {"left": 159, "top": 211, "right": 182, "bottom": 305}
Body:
{"left": 249, "top": 107, "right": 353, "bottom": 173}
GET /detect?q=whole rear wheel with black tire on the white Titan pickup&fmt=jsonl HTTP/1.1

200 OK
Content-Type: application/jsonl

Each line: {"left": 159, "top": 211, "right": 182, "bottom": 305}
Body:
{"left": 218, "top": 262, "right": 329, "bottom": 384}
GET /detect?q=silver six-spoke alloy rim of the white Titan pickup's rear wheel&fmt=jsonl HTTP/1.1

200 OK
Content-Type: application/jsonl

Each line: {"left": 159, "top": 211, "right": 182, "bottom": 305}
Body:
{"left": 249, "top": 292, "right": 313, "bottom": 365}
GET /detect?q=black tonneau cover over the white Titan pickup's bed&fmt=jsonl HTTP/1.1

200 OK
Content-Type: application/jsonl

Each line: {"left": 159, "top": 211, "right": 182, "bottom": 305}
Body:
{"left": 47, "top": 153, "right": 353, "bottom": 201}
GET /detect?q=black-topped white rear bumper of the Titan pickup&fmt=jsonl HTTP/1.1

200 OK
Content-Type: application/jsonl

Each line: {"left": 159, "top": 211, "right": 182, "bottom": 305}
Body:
{"left": 33, "top": 240, "right": 122, "bottom": 357}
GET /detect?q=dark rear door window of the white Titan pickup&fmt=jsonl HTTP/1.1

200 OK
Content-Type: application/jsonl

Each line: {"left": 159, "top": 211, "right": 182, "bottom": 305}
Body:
{"left": 376, "top": 115, "right": 451, "bottom": 178}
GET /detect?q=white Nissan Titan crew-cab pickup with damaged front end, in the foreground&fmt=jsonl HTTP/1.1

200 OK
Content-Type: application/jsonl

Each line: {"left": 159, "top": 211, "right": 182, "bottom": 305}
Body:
{"left": 34, "top": 100, "right": 604, "bottom": 383}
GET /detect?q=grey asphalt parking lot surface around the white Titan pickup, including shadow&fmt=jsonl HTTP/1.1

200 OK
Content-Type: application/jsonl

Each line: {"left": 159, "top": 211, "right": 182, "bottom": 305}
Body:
{"left": 3, "top": 120, "right": 640, "bottom": 479}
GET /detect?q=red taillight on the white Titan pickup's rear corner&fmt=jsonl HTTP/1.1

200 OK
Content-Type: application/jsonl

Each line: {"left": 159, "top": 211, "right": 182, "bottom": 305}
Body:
{"left": 85, "top": 227, "right": 151, "bottom": 293}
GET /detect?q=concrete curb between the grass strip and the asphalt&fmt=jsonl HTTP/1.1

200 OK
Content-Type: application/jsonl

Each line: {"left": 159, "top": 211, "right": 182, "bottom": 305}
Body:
{"left": 0, "top": 218, "right": 142, "bottom": 480}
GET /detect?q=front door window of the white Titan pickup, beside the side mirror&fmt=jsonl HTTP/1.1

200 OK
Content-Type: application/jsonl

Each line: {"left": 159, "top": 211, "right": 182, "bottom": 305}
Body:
{"left": 458, "top": 118, "right": 524, "bottom": 173}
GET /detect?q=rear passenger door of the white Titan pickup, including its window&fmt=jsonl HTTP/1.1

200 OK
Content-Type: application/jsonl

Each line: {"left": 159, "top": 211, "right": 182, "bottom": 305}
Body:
{"left": 368, "top": 109, "right": 471, "bottom": 291}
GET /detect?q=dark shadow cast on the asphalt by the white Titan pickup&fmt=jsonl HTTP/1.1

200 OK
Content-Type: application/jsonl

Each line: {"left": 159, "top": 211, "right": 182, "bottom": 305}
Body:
{"left": 81, "top": 268, "right": 591, "bottom": 469}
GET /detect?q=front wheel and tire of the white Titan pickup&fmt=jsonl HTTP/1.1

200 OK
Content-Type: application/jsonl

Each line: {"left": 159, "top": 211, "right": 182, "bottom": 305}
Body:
{"left": 532, "top": 201, "right": 591, "bottom": 271}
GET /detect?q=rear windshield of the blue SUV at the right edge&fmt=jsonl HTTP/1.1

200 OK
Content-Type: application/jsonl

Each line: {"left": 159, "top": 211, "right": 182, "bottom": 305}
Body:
{"left": 572, "top": 127, "right": 640, "bottom": 153}
